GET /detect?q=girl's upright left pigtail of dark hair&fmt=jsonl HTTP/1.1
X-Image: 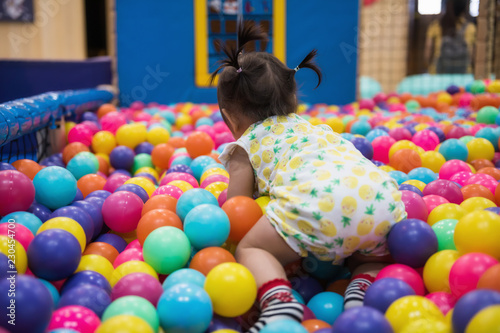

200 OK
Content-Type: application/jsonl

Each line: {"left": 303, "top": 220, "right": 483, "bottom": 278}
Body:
{"left": 210, "top": 20, "right": 267, "bottom": 84}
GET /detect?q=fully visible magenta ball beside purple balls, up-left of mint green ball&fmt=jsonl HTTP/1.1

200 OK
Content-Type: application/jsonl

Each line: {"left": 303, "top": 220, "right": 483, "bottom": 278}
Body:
{"left": 102, "top": 191, "right": 144, "bottom": 232}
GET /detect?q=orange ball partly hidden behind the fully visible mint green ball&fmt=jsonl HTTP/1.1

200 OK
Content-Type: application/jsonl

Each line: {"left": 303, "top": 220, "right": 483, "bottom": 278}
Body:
{"left": 137, "top": 209, "right": 182, "bottom": 245}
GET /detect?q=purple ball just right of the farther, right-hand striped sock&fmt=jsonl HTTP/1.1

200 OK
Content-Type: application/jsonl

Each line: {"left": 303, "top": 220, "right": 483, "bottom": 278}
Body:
{"left": 363, "top": 278, "right": 415, "bottom": 313}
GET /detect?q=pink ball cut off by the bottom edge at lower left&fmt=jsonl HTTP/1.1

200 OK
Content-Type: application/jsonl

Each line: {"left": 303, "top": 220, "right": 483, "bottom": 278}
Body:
{"left": 47, "top": 305, "right": 101, "bottom": 333}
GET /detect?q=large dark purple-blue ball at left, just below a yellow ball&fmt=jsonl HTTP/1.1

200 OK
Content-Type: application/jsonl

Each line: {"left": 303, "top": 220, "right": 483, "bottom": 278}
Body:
{"left": 27, "top": 229, "right": 82, "bottom": 281}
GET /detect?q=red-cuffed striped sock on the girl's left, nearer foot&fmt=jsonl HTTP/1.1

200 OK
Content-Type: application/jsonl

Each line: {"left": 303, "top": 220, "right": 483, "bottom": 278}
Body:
{"left": 248, "top": 279, "right": 304, "bottom": 333}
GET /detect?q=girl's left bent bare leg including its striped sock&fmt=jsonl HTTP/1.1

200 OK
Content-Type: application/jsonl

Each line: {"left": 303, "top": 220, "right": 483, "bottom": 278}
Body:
{"left": 236, "top": 216, "right": 304, "bottom": 333}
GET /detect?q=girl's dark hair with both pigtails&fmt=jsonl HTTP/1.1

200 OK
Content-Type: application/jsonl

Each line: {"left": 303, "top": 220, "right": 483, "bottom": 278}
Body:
{"left": 211, "top": 21, "right": 321, "bottom": 121}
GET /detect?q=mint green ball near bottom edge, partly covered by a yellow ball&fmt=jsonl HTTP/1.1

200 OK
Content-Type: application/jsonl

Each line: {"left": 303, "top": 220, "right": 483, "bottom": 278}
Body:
{"left": 102, "top": 296, "right": 160, "bottom": 332}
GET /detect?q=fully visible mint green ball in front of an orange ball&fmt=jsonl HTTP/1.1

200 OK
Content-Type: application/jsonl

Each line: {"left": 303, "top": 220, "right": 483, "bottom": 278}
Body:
{"left": 142, "top": 227, "right": 191, "bottom": 274}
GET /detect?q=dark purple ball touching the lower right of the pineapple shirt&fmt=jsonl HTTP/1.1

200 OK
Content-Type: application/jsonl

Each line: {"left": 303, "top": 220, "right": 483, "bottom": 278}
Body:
{"left": 387, "top": 219, "right": 438, "bottom": 268}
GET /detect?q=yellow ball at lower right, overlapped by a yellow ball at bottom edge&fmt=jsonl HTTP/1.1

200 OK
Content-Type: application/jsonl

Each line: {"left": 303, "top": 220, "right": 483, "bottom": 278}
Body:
{"left": 385, "top": 296, "right": 446, "bottom": 332}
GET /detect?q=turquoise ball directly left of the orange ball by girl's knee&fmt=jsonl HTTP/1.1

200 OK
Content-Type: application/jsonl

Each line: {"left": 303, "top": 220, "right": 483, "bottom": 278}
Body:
{"left": 184, "top": 204, "right": 230, "bottom": 250}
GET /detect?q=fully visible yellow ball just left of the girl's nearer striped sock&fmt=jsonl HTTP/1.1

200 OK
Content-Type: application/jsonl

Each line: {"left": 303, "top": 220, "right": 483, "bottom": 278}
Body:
{"left": 205, "top": 262, "right": 257, "bottom": 317}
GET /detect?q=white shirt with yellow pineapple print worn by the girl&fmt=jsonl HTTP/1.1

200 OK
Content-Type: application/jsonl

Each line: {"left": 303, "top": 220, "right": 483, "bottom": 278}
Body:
{"left": 219, "top": 114, "right": 406, "bottom": 263}
